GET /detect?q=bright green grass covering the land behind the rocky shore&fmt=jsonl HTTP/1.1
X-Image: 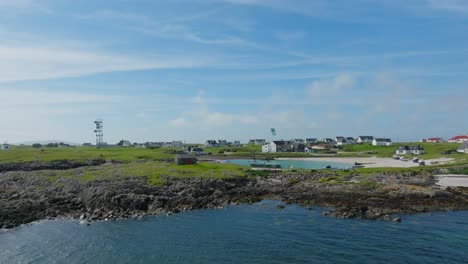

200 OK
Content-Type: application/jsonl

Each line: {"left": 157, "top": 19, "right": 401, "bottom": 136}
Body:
{"left": 0, "top": 143, "right": 468, "bottom": 179}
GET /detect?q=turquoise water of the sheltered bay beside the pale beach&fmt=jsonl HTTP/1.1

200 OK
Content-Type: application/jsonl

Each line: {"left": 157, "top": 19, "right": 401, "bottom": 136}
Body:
{"left": 226, "top": 159, "right": 353, "bottom": 170}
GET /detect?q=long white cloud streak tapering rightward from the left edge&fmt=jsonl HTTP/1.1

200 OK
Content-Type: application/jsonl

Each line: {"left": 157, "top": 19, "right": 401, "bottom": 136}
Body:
{"left": 0, "top": 45, "right": 203, "bottom": 82}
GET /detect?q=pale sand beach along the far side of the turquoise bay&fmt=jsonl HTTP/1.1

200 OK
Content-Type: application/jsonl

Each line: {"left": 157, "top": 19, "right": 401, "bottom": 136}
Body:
{"left": 278, "top": 157, "right": 453, "bottom": 168}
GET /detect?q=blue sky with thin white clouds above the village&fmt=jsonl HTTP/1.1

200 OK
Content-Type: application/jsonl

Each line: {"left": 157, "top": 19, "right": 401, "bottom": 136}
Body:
{"left": 0, "top": 0, "right": 468, "bottom": 143}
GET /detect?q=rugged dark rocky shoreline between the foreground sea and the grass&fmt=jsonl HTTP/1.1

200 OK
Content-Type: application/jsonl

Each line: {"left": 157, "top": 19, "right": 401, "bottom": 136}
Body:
{"left": 0, "top": 161, "right": 468, "bottom": 228}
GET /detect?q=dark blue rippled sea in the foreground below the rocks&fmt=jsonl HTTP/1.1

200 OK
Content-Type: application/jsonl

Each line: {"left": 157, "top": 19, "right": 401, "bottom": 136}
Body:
{"left": 0, "top": 201, "right": 468, "bottom": 264}
